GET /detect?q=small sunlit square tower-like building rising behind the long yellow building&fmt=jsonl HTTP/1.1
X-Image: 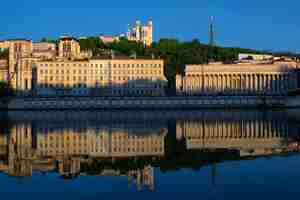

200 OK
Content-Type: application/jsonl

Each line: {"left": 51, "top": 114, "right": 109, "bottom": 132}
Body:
{"left": 58, "top": 36, "right": 80, "bottom": 60}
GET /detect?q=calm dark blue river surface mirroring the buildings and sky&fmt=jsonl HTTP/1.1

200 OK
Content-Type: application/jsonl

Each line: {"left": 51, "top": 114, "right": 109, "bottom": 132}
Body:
{"left": 0, "top": 110, "right": 300, "bottom": 200}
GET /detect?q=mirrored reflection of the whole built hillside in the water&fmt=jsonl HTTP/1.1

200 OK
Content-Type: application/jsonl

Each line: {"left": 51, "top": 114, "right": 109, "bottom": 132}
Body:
{"left": 0, "top": 112, "right": 299, "bottom": 190}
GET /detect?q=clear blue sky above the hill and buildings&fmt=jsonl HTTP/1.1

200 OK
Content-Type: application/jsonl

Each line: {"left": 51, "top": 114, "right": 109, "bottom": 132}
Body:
{"left": 0, "top": 0, "right": 300, "bottom": 53}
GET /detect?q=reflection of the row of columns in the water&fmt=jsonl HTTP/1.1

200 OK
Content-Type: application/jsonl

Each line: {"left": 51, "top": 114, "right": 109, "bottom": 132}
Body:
{"left": 176, "top": 120, "right": 289, "bottom": 141}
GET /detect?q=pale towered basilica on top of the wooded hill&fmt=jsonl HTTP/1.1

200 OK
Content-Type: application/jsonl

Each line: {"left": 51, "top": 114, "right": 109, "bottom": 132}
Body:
{"left": 126, "top": 19, "right": 153, "bottom": 46}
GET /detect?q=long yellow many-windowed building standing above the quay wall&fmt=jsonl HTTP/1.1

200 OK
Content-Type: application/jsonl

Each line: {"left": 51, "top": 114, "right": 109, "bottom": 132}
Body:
{"left": 36, "top": 58, "right": 166, "bottom": 96}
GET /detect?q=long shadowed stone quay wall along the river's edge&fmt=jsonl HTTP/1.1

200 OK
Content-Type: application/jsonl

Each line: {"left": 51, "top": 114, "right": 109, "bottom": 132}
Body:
{"left": 2, "top": 96, "right": 286, "bottom": 110}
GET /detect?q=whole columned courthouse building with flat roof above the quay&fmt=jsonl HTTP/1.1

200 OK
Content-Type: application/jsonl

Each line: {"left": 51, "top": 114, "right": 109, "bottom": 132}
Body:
{"left": 176, "top": 62, "right": 297, "bottom": 96}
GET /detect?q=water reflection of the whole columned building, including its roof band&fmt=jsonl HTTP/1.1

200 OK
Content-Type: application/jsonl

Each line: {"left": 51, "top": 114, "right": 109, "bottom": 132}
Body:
{"left": 176, "top": 119, "right": 289, "bottom": 151}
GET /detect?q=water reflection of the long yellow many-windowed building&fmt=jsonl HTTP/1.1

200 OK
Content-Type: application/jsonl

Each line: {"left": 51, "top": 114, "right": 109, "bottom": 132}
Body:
{"left": 37, "top": 128, "right": 167, "bottom": 158}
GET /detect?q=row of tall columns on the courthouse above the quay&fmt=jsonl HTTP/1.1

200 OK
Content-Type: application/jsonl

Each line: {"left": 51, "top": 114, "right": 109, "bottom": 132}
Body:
{"left": 177, "top": 72, "right": 297, "bottom": 95}
